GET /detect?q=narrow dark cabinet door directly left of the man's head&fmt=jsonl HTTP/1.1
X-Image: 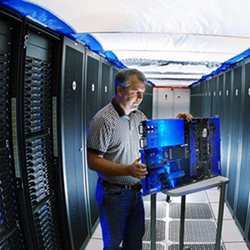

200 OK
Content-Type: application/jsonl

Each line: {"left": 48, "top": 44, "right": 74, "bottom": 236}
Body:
{"left": 100, "top": 60, "right": 112, "bottom": 107}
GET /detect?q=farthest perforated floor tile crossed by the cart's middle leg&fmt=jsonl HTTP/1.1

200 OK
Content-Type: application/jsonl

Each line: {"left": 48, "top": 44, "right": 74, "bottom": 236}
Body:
{"left": 169, "top": 203, "right": 212, "bottom": 219}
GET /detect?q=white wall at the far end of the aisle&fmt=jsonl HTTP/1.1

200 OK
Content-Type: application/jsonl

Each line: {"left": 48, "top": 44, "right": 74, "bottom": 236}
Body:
{"left": 153, "top": 87, "right": 190, "bottom": 119}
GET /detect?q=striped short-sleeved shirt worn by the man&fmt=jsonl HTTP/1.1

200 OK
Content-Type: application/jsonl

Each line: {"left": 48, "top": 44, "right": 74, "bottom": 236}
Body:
{"left": 87, "top": 99, "right": 147, "bottom": 184}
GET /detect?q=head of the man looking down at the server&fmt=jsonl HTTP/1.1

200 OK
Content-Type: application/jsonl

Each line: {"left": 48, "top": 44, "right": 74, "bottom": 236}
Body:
{"left": 115, "top": 69, "right": 146, "bottom": 114}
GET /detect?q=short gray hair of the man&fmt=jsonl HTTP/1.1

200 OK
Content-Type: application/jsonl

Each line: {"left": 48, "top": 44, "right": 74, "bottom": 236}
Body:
{"left": 115, "top": 69, "right": 146, "bottom": 93}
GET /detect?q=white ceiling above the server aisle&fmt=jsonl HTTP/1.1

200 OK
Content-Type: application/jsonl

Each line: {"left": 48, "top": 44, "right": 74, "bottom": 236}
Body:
{"left": 32, "top": 0, "right": 250, "bottom": 86}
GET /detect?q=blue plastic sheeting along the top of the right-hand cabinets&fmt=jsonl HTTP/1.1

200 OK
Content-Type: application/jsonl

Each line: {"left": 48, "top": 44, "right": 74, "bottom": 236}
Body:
{"left": 191, "top": 49, "right": 250, "bottom": 86}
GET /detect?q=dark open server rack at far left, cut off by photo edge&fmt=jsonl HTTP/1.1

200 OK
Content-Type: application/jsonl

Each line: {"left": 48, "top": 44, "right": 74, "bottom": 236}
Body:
{"left": 0, "top": 13, "right": 27, "bottom": 250}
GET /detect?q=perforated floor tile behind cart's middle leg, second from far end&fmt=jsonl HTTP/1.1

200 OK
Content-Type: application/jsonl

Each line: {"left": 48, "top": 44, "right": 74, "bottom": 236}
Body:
{"left": 169, "top": 221, "right": 216, "bottom": 243}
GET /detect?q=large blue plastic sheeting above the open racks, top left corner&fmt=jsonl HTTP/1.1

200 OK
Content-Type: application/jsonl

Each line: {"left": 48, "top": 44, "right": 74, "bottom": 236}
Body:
{"left": 0, "top": 0, "right": 75, "bottom": 38}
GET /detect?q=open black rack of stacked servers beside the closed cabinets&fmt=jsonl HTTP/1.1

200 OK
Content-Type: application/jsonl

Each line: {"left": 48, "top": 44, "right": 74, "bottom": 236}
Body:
{"left": 16, "top": 24, "right": 61, "bottom": 250}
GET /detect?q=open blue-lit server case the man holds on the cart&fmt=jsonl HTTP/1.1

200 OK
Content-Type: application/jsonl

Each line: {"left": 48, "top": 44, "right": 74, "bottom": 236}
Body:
{"left": 140, "top": 117, "right": 221, "bottom": 195}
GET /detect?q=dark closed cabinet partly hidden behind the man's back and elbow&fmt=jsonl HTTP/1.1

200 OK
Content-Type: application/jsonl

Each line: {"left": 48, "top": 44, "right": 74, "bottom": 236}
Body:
{"left": 85, "top": 51, "right": 101, "bottom": 231}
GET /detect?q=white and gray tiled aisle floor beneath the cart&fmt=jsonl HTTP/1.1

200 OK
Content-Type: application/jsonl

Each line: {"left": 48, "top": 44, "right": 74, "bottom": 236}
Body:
{"left": 86, "top": 188, "right": 248, "bottom": 250}
